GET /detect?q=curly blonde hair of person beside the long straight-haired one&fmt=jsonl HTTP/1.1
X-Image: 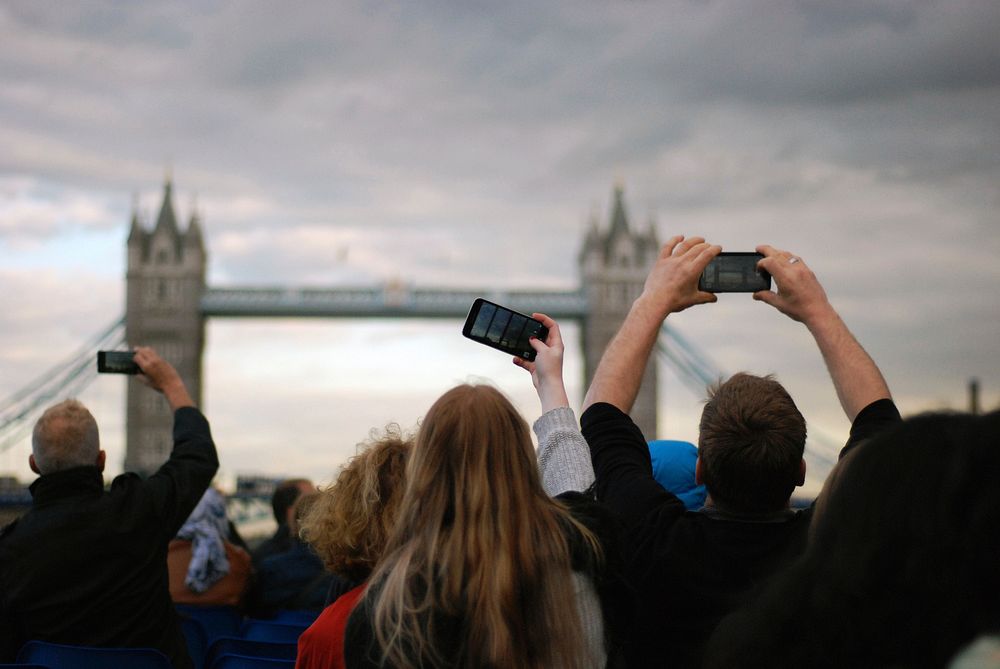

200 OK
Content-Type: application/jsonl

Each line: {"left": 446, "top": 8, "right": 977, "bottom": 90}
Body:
{"left": 300, "top": 424, "right": 413, "bottom": 583}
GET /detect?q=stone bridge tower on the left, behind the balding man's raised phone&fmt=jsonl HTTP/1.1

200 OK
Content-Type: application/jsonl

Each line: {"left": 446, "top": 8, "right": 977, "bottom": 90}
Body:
{"left": 125, "top": 179, "right": 206, "bottom": 476}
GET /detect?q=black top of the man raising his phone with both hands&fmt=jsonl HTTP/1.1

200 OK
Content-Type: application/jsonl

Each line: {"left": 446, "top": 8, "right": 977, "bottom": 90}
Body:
{"left": 580, "top": 400, "right": 899, "bottom": 669}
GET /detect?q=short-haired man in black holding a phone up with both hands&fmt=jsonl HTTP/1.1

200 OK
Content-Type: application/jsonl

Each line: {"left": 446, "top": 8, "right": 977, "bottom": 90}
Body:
{"left": 580, "top": 236, "right": 900, "bottom": 667}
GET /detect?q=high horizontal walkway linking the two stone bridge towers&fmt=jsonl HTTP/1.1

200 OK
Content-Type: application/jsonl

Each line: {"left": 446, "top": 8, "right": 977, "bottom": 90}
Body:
{"left": 201, "top": 284, "right": 587, "bottom": 320}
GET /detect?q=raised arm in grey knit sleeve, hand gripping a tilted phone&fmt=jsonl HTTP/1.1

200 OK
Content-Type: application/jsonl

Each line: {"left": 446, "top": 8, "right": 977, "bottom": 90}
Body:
{"left": 514, "top": 313, "right": 594, "bottom": 497}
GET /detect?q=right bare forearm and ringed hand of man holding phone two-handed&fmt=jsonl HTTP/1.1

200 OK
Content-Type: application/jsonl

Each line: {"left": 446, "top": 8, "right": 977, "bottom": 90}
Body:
{"left": 753, "top": 245, "right": 891, "bottom": 422}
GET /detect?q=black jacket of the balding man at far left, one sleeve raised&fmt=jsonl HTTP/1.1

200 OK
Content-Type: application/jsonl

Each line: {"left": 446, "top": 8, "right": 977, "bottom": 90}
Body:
{"left": 0, "top": 408, "right": 219, "bottom": 667}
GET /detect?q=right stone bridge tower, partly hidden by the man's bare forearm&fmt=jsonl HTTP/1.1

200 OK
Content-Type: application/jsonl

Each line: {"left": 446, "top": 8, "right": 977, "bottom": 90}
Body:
{"left": 580, "top": 185, "right": 660, "bottom": 439}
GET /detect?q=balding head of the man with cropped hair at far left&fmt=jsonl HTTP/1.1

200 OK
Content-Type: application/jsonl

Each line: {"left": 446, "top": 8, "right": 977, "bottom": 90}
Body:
{"left": 28, "top": 400, "right": 105, "bottom": 474}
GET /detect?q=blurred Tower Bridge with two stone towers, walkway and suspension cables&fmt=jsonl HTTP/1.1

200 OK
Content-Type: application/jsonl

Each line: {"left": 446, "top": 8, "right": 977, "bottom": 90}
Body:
{"left": 0, "top": 181, "right": 839, "bottom": 500}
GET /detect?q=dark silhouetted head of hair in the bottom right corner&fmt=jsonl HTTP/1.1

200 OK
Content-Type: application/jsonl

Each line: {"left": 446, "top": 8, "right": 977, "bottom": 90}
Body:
{"left": 710, "top": 412, "right": 1000, "bottom": 667}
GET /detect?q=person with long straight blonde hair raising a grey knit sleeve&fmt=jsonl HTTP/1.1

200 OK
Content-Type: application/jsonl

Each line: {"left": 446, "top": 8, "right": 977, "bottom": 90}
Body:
{"left": 344, "top": 314, "right": 613, "bottom": 669}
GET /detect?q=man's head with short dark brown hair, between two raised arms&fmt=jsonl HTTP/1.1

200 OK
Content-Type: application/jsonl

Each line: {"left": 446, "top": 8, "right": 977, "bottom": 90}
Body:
{"left": 698, "top": 372, "right": 806, "bottom": 512}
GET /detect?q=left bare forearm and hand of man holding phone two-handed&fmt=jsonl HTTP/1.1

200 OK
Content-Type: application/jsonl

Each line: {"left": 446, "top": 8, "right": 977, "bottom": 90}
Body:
{"left": 583, "top": 236, "right": 722, "bottom": 413}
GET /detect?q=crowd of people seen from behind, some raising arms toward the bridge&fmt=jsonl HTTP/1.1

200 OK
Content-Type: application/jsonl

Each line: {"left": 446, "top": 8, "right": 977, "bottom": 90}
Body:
{"left": 0, "top": 237, "right": 1000, "bottom": 669}
